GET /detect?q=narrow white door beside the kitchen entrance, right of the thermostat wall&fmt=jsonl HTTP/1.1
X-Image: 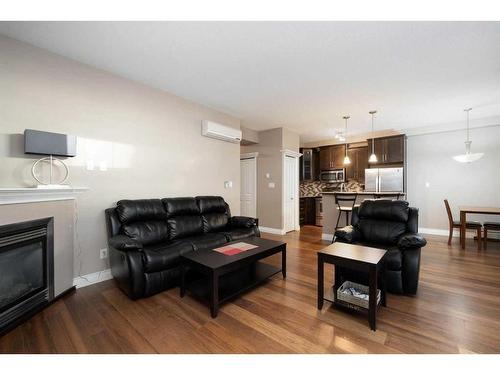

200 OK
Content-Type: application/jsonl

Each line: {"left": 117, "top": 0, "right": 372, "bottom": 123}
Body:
{"left": 283, "top": 156, "right": 298, "bottom": 232}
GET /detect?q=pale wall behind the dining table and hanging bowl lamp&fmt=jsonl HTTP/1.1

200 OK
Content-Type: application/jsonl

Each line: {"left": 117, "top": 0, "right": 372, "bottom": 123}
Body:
{"left": 407, "top": 125, "right": 500, "bottom": 229}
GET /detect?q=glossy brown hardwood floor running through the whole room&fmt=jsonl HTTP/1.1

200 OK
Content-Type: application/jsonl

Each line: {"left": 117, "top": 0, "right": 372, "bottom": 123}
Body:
{"left": 0, "top": 227, "right": 500, "bottom": 353}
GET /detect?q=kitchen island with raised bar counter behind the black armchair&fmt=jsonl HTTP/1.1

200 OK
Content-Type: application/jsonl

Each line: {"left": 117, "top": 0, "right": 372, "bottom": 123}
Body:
{"left": 322, "top": 191, "right": 405, "bottom": 241}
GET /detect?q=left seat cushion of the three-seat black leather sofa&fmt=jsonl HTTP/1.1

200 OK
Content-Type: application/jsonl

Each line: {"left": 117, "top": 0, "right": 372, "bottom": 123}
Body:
{"left": 142, "top": 241, "right": 193, "bottom": 272}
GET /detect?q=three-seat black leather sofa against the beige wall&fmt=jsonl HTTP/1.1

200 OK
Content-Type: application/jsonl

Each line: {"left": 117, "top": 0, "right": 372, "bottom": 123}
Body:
{"left": 105, "top": 196, "right": 260, "bottom": 299}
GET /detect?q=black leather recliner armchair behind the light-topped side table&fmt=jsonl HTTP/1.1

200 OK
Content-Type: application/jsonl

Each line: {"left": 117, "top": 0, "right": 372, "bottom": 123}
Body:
{"left": 334, "top": 199, "right": 427, "bottom": 294}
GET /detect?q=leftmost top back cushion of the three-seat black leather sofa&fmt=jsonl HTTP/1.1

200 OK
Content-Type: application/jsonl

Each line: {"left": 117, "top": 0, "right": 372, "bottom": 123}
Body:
{"left": 116, "top": 199, "right": 166, "bottom": 224}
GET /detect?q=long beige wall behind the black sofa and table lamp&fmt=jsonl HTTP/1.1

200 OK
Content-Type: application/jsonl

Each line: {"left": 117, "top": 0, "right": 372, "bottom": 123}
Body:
{"left": 0, "top": 36, "right": 240, "bottom": 274}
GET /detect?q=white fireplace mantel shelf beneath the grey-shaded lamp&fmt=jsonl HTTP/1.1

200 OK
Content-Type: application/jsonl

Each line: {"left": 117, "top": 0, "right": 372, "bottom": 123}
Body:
{"left": 0, "top": 187, "right": 89, "bottom": 205}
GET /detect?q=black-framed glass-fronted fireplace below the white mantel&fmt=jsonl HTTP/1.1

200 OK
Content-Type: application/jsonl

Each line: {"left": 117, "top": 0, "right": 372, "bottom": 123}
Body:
{"left": 0, "top": 217, "right": 54, "bottom": 334}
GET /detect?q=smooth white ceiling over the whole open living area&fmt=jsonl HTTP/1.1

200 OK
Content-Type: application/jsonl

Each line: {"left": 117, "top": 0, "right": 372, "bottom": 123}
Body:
{"left": 0, "top": 22, "right": 500, "bottom": 142}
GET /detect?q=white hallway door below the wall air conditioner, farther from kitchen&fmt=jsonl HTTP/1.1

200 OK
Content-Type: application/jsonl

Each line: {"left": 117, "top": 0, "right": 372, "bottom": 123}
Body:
{"left": 240, "top": 158, "right": 257, "bottom": 217}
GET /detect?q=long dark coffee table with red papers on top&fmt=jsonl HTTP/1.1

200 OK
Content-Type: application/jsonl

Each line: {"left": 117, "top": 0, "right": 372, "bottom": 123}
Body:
{"left": 180, "top": 237, "right": 286, "bottom": 318}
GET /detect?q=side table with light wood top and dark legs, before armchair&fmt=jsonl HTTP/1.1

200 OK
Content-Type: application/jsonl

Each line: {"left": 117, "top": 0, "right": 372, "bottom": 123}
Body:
{"left": 318, "top": 242, "right": 387, "bottom": 331}
